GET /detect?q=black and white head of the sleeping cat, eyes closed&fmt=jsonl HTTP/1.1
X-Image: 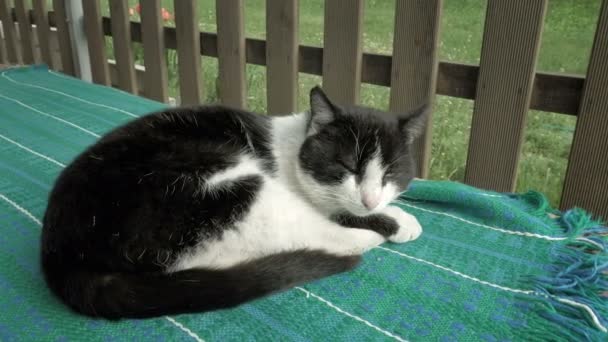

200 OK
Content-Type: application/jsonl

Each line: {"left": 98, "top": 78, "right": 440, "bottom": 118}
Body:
{"left": 297, "top": 87, "right": 427, "bottom": 216}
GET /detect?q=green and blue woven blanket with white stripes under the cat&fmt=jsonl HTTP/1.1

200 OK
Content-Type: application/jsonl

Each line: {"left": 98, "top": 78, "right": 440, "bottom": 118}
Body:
{"left": 0, "top": 67, "right": 608, "bottom": 341}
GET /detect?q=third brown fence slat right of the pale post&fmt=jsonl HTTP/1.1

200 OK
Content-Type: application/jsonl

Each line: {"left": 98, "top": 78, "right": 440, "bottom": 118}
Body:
{"left": 140, "top": 0, "right": 168, "bottom": 102}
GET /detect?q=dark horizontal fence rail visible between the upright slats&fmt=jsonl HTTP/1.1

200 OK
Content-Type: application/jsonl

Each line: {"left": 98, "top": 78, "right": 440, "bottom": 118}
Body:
{"left": 97, "top": 16, "right": 585, "bottom": 116}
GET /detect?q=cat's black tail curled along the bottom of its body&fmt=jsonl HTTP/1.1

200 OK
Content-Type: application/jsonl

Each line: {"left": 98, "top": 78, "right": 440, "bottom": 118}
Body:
{"left": 47, "top": 250, "right": 360, "bottom": 319}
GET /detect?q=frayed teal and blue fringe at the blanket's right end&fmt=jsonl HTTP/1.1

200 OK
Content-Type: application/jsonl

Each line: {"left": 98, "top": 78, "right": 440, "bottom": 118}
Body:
{"left": 534, "top": 207, "right": 608, "bottom": 341}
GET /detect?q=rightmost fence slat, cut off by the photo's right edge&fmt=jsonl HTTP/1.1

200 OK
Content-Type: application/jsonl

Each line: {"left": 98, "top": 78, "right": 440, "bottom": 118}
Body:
{"left": 560, "top": 0, "right": 608, "bottom": 219}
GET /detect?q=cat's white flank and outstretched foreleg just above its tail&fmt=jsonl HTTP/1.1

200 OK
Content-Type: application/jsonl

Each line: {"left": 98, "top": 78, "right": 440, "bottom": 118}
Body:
{"left": 173, "top": 178, "right": 386, "bottom": 270}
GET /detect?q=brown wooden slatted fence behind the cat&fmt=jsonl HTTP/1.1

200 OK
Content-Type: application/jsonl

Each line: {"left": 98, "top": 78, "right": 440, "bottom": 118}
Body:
{"left": 0, "top": 0, "right": 608, "bottom": 218}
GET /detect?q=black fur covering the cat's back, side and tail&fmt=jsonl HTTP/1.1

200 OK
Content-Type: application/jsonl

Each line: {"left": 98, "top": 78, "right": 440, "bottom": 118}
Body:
{"left": 41, "top": 107, "right": 346, "bottom": 318}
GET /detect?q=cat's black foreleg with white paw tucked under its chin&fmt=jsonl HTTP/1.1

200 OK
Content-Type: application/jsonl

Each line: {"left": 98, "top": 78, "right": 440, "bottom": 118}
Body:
{"left": 331, "top": 206, "right": 422, "bottom": 243}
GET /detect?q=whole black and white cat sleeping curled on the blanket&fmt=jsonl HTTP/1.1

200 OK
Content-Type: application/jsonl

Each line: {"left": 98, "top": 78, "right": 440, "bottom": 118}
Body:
{"left": 41, "top": 87, "right": 425, "bottom": 319}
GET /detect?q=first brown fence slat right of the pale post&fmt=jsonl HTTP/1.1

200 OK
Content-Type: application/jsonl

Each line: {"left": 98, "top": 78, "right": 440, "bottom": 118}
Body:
{"left": 82, "top": 0, "right": 110, "bottom": 85}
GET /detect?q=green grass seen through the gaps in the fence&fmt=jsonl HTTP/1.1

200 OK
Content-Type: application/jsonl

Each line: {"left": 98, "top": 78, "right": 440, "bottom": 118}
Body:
{"left": 102, "top": 0, "right": 600, "bottom": 205}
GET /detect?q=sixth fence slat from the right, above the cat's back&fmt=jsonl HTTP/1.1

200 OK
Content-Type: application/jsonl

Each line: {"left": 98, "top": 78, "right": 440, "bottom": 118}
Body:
{"left": 215, "top": 0, "right": 246, "bottom": 108}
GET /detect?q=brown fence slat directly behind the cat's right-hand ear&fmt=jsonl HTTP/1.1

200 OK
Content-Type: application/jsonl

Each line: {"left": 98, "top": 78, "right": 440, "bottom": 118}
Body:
{"left": 390, "top": 0, "right": 443, "bottom": 178}
